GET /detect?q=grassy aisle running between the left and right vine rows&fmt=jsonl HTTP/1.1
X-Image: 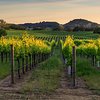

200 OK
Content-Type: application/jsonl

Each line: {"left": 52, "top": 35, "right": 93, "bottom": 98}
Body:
{"left": 21, "top": 46, "right": 63, "bottom": 93}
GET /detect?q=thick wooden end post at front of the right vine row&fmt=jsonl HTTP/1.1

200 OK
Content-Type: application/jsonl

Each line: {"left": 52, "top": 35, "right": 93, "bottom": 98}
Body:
{"left": 72, "top": 46, "right": 76, "bottom": 87}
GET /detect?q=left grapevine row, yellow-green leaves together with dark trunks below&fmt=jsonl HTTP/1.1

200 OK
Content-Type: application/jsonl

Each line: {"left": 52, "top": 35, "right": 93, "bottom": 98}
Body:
{"left": 0, "top": 34, "right": 55, "bottom": 82}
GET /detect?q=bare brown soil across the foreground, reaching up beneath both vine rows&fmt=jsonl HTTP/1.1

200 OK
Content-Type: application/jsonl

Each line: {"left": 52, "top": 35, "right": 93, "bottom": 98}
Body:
{"left": 0, "top": 68, "right": 100, "bottom": 100}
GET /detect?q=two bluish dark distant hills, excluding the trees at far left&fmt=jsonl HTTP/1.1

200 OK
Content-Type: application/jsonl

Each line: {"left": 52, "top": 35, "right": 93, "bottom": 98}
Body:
{"left": 20, "top": 19, "right": 100, "bottom": 30}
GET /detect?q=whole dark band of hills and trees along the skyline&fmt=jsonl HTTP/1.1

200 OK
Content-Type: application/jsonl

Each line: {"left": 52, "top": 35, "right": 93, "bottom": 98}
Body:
{"left": 0, "top": 19, "right": 100, "bottom": 31}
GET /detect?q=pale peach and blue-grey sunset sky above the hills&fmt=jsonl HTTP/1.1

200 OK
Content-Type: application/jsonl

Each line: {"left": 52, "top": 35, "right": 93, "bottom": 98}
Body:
{"left": 0, "top": 0, "right": 100, "bottom": 24}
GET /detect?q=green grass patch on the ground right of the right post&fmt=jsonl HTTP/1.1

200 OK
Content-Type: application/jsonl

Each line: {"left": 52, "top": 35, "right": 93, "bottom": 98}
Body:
{"left": 77, "top": 58, "right": 100, "bottom": 94}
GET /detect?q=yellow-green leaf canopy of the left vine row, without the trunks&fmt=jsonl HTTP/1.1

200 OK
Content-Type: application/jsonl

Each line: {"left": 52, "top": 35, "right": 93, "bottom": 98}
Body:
{"left": 0, "top": 34, "right": 51, "bottom": 59}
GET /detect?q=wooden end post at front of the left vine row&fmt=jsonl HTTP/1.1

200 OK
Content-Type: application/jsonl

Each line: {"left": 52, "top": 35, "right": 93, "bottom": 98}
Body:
{"left": 11, "top": 45, "right": 14, "bottom": 84}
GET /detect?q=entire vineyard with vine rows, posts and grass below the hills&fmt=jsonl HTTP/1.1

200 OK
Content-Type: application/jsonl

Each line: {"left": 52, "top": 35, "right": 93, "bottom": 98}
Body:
{"left": 0, "top": 31, "right": 100, "bottom": 99}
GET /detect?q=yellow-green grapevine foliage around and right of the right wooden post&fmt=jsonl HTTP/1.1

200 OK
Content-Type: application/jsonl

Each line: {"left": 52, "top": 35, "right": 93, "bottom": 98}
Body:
{"left": 61, "top": 36, "right": 100, "bottom": 66}
